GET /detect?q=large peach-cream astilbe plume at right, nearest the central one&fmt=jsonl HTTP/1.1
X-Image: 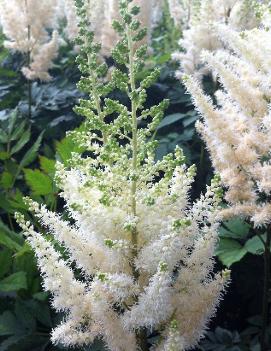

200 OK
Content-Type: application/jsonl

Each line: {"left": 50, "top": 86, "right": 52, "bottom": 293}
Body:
{"left": 185, "top": 25, "right": 271, "bottom": 226}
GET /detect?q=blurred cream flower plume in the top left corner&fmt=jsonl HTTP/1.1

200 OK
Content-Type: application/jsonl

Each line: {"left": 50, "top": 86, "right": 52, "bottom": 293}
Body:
{"left": 0, "top": 0, "right": 59, "bottom": 81}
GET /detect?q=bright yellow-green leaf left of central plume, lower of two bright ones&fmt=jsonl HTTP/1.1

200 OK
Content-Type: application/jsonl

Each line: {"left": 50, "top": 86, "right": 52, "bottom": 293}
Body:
{"left": 24, "top": 169, "right": 53, "bottom": 195}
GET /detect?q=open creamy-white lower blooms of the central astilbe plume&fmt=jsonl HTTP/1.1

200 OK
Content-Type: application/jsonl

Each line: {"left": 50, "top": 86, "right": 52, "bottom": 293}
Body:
{"left": 18, "top": 159, "right": 227, "bottom": 351}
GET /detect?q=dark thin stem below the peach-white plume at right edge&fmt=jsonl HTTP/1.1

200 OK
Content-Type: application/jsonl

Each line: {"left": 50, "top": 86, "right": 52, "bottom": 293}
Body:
{"left": 260, "top": 226, "right": 271, "bottom": 351}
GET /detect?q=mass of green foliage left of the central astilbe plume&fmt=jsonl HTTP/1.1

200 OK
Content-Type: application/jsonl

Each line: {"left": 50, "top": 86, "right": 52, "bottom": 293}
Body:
{"left": 0, "top": 29, "right": 83, "bottom": 351}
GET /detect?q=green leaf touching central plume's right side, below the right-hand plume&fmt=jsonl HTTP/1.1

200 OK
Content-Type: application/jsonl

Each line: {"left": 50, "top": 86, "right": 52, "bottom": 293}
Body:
{"left": 216, "top": 238, "right": 247, "bottom": 267}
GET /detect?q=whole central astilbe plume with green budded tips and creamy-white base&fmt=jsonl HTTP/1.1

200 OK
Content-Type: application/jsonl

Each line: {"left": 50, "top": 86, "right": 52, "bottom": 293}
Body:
{"left": 17, "top": 0, "right": 231, "bottom": 351}
